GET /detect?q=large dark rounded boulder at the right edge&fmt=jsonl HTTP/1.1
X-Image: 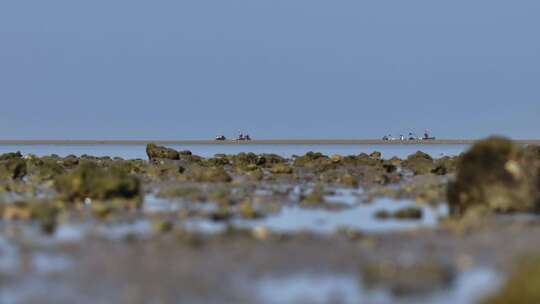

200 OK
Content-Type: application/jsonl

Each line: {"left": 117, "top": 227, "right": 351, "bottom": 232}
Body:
{"left": 448, "top": 137, "right": 540, "bottom": 215}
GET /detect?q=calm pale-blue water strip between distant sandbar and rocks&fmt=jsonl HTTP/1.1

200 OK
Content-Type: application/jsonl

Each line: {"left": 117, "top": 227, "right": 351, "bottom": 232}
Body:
{"left": 0, "top": 144, "right": 468, "bottom": 159}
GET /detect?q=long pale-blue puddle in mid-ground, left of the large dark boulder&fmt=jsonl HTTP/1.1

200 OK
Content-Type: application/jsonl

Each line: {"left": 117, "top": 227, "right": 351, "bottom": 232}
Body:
{"left": 235, "top": 198, "right": 448, "bottom": 233}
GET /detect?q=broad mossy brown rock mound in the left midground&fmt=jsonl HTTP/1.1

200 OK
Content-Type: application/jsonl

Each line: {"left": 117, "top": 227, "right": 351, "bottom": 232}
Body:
{"left": 55, "top": 162, "right": 141, "bottom": 201}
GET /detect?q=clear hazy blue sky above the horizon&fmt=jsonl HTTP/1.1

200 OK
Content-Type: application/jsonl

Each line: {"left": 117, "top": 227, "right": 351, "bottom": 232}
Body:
{"left": 0, "top": 0, "right": 540, "bottom": 139}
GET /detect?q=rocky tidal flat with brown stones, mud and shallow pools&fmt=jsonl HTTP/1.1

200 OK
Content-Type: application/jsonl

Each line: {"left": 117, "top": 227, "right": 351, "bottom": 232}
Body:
{"left": 0, "top": 137, "right": 540, "bottom": 303}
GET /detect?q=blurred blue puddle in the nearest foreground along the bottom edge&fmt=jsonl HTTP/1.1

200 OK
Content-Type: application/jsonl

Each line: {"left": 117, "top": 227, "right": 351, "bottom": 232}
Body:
{"left": 255, "top": 269, "right": 501, "bottom": 304}
